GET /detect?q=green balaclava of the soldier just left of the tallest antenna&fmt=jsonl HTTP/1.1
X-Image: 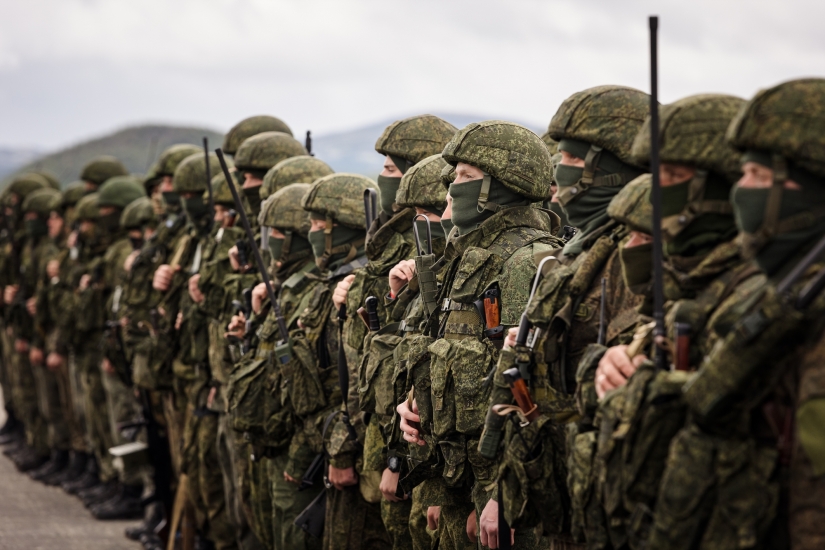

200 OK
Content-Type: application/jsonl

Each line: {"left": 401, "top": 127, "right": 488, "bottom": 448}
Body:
{"left": 555, "top": 139, "right": 642, "bottom": 242}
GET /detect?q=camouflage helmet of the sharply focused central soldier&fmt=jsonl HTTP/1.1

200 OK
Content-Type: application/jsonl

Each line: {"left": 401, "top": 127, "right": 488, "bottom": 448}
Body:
{"left": 443, "top": 120, "right": 553, "bottom": 201}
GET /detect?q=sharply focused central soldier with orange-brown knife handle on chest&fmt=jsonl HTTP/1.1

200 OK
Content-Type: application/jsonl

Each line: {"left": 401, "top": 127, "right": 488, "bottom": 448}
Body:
{"left": 398, "top": 121, "right": 561, "bottom": 548}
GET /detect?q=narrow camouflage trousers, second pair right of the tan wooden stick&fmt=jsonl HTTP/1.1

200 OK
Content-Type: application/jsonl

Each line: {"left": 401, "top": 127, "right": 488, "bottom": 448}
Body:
{"left": 215, "top": 414, "right": 264, "bottom": 550}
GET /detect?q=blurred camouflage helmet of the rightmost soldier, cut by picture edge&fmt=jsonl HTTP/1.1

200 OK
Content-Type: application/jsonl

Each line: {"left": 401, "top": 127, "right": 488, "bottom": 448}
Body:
{"left": 727, "top": 78, "right": 825, "bottom": 177}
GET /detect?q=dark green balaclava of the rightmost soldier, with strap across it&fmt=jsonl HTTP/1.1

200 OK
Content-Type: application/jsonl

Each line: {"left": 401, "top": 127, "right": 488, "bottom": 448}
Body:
{"left": 731, "top": 151, "right": 825, "bottom": 277}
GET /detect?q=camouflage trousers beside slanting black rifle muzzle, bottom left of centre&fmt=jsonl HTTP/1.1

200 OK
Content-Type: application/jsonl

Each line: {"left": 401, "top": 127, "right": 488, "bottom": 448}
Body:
{"left": 266, "top": 452, "right": 324, "bottom": 550}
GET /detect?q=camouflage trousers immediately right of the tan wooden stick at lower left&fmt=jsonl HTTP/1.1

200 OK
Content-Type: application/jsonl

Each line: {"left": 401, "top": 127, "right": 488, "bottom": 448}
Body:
{"left": 182, "top": 403, "right": 238, "bottom": 550}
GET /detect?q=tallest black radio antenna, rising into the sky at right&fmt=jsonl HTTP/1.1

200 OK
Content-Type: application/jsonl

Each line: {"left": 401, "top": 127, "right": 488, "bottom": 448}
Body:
{"left": 648, "top": 15, "right": 668, "bottom": 370}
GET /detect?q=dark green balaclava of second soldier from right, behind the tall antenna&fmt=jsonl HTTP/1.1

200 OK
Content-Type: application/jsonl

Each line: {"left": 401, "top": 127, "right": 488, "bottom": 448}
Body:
{"left": 661, "top": 170, "right": 736, "bottom": 256}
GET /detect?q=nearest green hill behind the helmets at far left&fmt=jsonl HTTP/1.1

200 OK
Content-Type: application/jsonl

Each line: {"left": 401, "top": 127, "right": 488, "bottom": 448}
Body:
{"left": 2, "top": 125, "right": 223, "bottom": 187}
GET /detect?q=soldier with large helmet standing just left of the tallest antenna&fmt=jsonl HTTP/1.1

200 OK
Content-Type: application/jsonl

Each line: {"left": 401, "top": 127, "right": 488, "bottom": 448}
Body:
{"left": 492, "top": 86, "right": 649, "bottom": 547}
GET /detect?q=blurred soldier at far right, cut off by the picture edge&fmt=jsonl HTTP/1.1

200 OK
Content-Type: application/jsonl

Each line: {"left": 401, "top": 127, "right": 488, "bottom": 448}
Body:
{"left": 648, "top": 79, "right": 825, "bottom": 549}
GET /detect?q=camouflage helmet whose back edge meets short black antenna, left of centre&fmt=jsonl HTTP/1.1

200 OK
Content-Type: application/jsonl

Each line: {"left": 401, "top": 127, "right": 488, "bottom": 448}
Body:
{"left": 301, "top": 174, "right": 377, "bottom": 230}
